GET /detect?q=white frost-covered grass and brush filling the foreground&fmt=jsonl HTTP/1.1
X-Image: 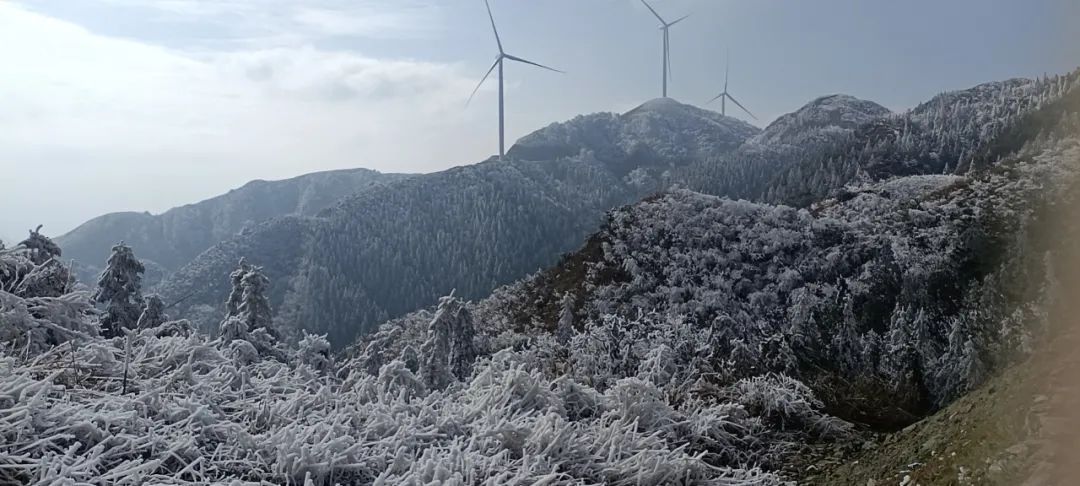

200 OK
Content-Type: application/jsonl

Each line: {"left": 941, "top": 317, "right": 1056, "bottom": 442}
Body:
{"left": 0, "top": 321, "right": 812, "bottom": 485}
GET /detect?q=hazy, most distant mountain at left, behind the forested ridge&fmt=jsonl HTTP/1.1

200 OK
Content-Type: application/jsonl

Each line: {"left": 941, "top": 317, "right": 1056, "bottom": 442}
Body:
{"left": 56, "top": 168, "right": 407, "bottom": 282}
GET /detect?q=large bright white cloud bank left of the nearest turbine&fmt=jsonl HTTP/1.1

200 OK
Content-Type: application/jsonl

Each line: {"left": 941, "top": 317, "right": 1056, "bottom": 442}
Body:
{"left": 0, "top": 0, "right": 489, "bottom": 234}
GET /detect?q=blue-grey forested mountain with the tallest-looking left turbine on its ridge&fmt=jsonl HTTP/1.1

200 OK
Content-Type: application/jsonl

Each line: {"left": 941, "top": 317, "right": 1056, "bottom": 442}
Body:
{"left": 161, "top": 99, "right": 758, "bottom": 346}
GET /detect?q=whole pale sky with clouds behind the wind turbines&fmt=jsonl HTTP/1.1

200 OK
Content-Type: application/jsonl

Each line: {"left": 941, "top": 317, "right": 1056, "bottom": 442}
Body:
{"left": 0, "top": 0, "right": 1080, "bottom": 243}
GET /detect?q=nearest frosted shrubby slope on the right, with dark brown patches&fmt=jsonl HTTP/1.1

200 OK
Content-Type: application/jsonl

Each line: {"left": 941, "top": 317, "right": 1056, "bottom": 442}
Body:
{"left": 358, "top": 71, "right": 1080, "bottom": 431}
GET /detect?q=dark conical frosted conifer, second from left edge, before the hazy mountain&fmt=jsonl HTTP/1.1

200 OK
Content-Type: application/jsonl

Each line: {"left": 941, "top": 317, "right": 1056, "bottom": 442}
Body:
{"left": 93, "top": 242, "right": 146, "bottom": 337}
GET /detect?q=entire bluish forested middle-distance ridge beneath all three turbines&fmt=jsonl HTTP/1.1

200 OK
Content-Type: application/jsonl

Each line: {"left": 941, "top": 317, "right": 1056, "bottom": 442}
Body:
{"left": 147, "top": 77, "right": 1069, "bottom": 346}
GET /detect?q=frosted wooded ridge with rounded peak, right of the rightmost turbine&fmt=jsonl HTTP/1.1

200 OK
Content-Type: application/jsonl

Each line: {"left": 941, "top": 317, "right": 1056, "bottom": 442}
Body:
{"left": 673, "top": 77, "right": 1068, "bottom": 206}
